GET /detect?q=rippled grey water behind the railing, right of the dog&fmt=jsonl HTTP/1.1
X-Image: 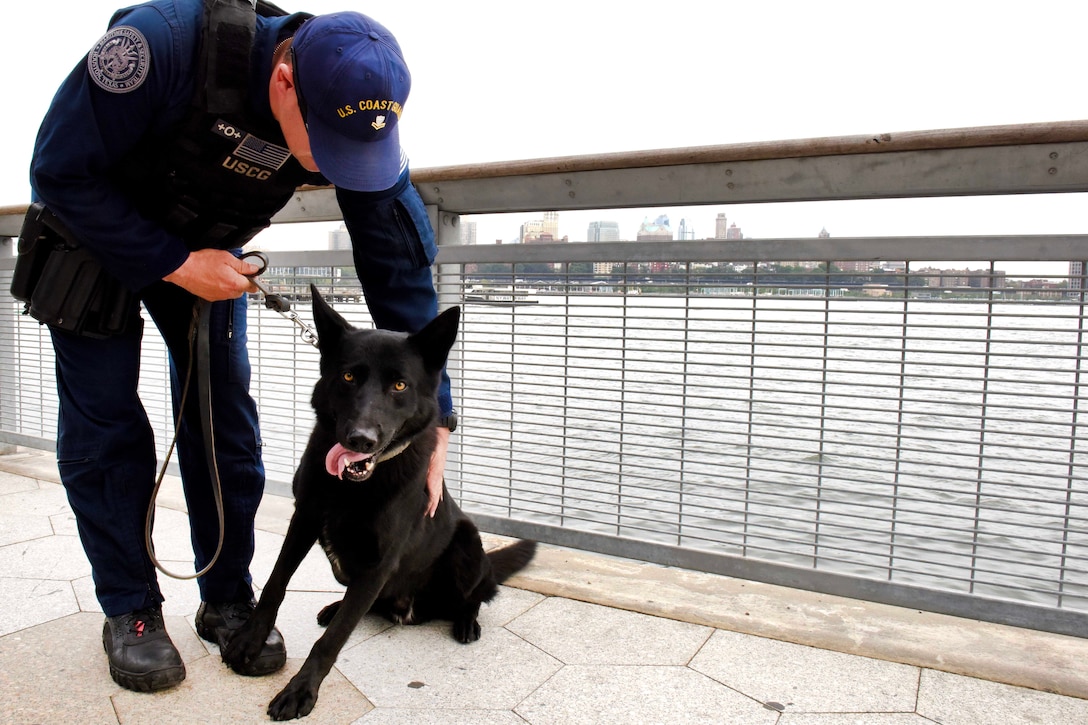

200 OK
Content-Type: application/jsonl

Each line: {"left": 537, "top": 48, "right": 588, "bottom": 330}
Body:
{"left": 417, "top": 295, "right": 1088, "bottom": 609}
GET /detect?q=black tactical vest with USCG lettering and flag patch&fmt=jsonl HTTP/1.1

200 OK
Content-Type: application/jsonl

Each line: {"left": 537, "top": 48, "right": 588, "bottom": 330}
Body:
{"left": 114, "top": 0, "right": 322, "bottom": 249}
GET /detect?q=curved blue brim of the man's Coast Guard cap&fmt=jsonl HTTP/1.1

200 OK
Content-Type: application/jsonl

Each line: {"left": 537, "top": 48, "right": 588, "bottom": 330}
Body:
{"left": 307, "top": 114, "right": 405, "bottom": 192}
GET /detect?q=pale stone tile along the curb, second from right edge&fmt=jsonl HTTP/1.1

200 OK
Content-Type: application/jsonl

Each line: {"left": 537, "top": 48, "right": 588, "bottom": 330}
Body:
{"left": 691, "top": 630, "right": 918, "bottom": 712}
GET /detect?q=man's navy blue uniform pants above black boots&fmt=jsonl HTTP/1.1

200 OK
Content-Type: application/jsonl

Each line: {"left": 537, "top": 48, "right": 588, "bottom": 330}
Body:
{"left": 51, "top": 282, "right": 264, "bottom": 616}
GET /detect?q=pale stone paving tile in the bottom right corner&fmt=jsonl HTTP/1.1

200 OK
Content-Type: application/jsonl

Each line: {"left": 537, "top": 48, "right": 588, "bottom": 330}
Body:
{"left": 917, "top": 669, "right": 1088, "bottom": 725}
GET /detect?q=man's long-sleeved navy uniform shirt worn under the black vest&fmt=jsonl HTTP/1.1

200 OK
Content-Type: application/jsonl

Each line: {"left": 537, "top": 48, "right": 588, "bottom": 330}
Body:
{"left": 30, "top": 0, "right": 453, "bottom": 415}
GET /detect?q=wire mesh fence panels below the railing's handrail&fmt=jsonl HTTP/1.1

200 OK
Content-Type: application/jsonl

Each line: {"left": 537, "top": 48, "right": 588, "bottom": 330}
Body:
{"left": 0, "top": 249, "right": 1088, "bottom": 631}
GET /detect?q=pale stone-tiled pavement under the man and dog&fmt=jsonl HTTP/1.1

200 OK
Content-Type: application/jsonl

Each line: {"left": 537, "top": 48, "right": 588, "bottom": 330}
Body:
{"left": 0, "top": 450, "right": 1088, "bottom": 725}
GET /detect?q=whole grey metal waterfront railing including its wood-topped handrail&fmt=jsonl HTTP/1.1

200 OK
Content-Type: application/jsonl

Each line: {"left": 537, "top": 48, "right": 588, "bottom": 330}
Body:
{"left": 0, "top": 124, "right": 1088, "bottom": 636}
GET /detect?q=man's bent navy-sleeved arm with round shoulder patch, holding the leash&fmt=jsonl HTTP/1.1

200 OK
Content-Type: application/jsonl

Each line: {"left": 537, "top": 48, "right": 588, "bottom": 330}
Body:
{"left": 30, "top": 7, "right": 193, "bottom": 290}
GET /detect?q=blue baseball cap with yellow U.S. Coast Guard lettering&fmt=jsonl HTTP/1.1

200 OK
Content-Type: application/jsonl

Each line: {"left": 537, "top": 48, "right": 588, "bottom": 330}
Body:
{"left": 292, "top": 12, "right": 411, "bottom": 192}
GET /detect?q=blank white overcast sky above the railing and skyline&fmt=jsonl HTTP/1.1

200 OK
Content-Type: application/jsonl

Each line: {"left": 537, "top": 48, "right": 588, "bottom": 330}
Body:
{"left": 0, "top": 0, "right": 1088, "bottom": 271}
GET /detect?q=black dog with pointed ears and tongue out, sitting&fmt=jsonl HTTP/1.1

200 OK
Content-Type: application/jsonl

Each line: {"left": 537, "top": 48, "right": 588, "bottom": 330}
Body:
{"left": 222, "top": 287, "right": 535, "bottom": 720}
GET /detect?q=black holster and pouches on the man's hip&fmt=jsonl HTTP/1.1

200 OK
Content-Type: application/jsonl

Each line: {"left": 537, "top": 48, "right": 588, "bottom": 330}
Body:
{"left": 11, "top": 202, "right": 141, "bottom": 337}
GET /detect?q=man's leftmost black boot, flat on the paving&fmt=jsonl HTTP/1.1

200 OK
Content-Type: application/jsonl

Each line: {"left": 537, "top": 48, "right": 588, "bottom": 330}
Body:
{"left": 102, "top": 606, "right": 185, "bottom": 692}
